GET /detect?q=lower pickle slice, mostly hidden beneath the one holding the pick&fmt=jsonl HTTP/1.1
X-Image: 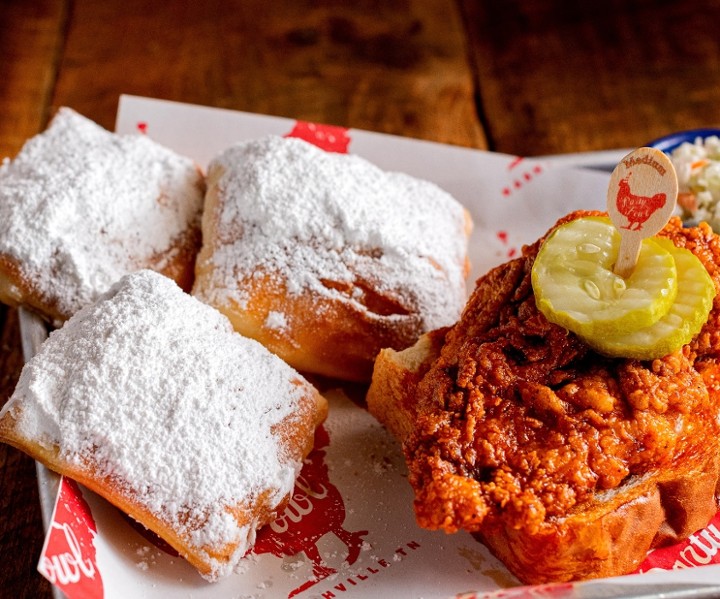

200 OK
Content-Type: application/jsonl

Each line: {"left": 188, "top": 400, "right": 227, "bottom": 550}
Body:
{"left": 584, "top": 239, "right": 715, "bottom": 360}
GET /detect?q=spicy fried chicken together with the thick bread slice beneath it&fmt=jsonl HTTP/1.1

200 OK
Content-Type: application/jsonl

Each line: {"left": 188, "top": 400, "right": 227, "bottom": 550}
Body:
{"left": 368, "top": 212, "right": 720, "bottom": 583}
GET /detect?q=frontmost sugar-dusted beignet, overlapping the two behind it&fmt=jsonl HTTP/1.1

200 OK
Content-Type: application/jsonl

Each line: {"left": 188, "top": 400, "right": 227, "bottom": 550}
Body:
{"left": 0, "top": 271, "right": 327, "bottom": 580}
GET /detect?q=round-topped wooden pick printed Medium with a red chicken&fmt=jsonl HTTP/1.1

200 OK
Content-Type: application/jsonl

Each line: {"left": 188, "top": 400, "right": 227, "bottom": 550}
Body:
{"left": 607, "top": 148, "right": 678, "bottom": 278}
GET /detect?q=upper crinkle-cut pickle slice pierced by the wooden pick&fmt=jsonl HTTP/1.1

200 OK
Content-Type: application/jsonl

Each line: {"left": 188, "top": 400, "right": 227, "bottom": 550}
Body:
{"left": 532, "top": 217, "right": 677, "bottom": 340}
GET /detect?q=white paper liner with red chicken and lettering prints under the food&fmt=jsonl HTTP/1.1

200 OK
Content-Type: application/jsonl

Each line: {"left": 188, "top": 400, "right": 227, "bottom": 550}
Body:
{"left": 21, "top": 96, "right": 720, "bottom": 599}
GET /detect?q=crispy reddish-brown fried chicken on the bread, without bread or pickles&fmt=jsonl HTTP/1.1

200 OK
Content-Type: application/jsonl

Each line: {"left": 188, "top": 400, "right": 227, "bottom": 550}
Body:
{"left": 404, "top": 212, "right": 720, "bottom": 535}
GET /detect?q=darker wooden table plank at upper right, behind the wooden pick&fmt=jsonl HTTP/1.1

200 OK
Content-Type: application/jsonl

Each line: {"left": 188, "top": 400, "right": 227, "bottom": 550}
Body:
{"left": 461, "top": 0, "right": 720, "bottom": 156}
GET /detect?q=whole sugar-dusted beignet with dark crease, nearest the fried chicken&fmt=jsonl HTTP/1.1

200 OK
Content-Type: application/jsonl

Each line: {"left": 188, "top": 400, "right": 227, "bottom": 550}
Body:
{"left": 193, "top": 136, "right": 471, "bottom": 380}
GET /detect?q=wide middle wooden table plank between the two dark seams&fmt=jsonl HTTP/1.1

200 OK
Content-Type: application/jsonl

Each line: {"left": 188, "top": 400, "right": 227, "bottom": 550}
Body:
{"left": 53, "top": 0, "right": 485, "bottom": 147}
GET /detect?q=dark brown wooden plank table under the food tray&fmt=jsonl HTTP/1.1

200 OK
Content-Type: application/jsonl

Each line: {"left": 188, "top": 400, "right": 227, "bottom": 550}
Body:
{"left": 0, "top": 0, "right": 720, "bottom": 598}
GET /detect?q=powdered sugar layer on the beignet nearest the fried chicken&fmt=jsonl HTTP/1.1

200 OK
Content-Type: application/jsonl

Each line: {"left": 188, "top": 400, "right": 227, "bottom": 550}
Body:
{"left": 194, "top": 136, "right": 467, "bottom": 330}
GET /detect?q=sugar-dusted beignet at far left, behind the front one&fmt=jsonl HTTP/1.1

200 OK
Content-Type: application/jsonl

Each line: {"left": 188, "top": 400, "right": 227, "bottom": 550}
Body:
{"left": 0, "top": 108, "right": 204, "bottom": 323}
